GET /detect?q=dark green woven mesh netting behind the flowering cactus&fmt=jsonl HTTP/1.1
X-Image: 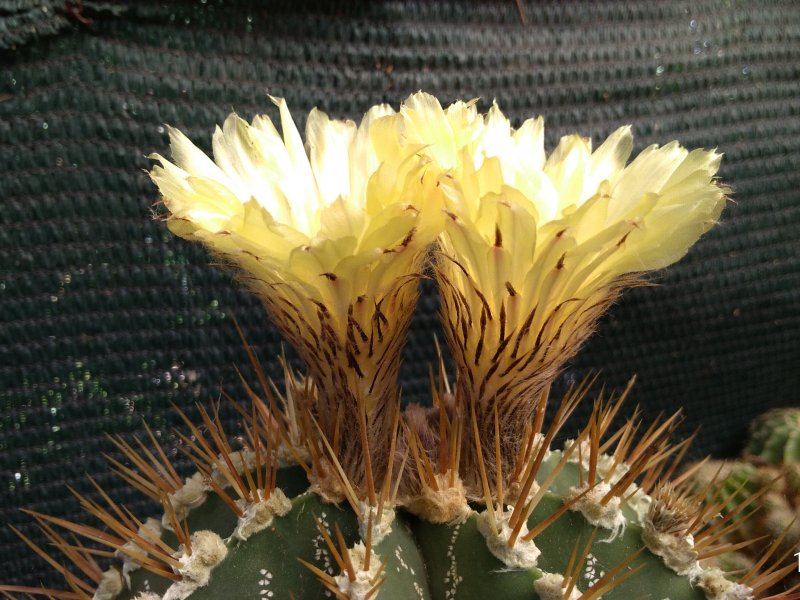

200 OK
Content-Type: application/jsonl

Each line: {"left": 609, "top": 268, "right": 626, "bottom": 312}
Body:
{"left": 0, "top": 0, "right": 800, "bottom": 584}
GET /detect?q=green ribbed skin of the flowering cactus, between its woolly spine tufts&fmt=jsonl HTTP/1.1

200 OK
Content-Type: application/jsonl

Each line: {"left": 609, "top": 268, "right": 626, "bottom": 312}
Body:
{"left": 108, "top": 452, "right": 720, "bottom": 600}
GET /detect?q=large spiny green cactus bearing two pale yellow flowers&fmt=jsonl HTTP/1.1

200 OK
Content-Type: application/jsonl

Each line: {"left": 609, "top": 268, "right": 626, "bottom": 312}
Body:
{"left": 0, "top": 93, "right": 793, "bottom": 600}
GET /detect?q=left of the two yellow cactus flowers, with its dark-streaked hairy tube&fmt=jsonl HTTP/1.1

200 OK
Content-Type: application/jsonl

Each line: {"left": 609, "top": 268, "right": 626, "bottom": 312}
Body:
{"left": 151, "top": 99, "right": 439, "bottom": 497}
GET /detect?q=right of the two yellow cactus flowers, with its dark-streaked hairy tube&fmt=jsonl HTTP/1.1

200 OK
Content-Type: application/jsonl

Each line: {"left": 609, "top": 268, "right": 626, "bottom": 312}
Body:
{"left": 394, "top": 94, "right": 729, "bottom": 488}
